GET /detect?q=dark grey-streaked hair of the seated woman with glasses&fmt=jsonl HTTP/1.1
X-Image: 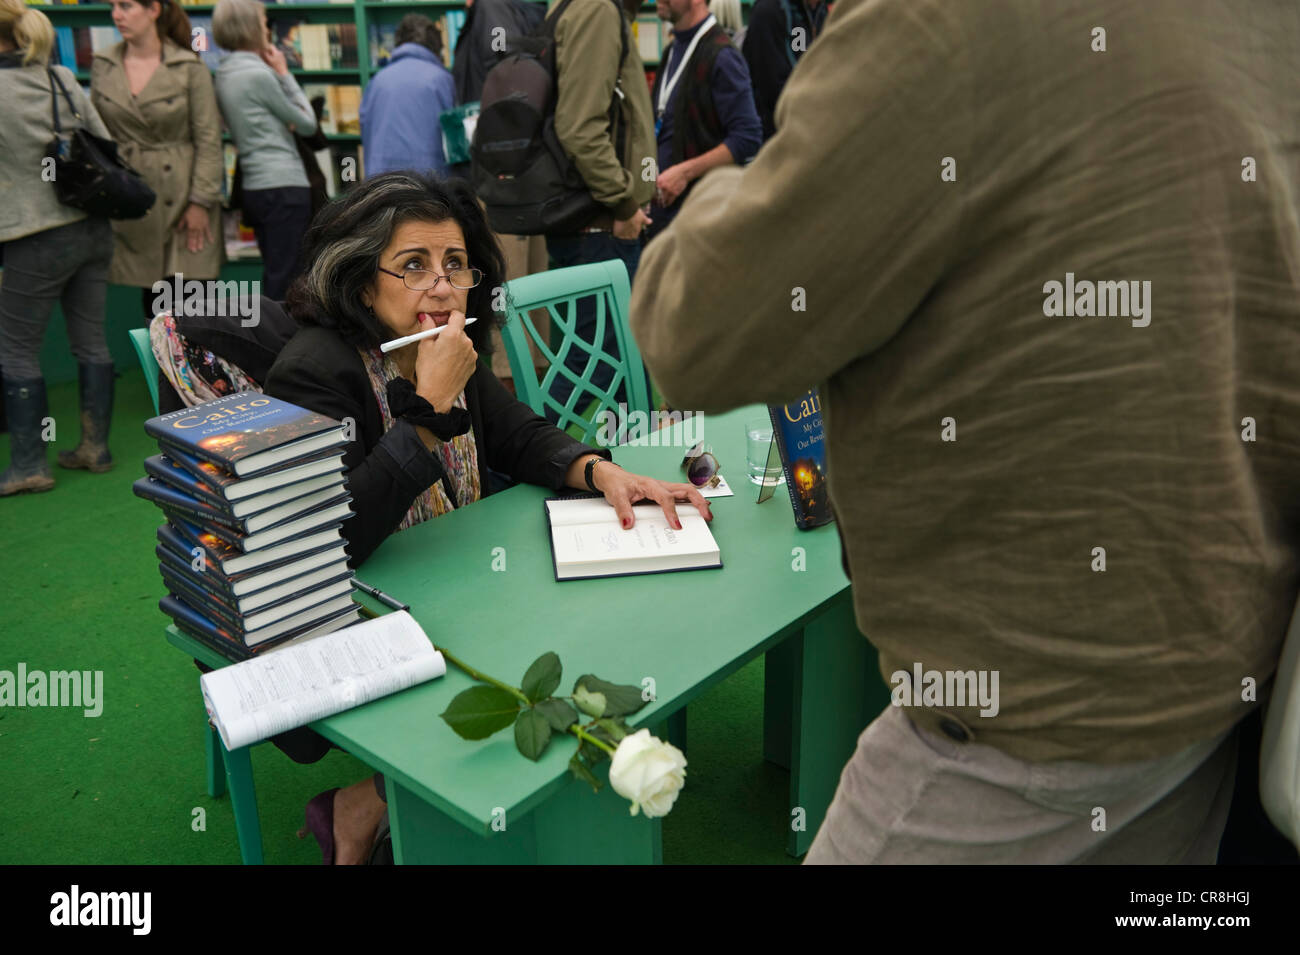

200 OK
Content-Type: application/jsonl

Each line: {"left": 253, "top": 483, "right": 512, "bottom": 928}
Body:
{"left": 285, "top": 172, "right": 506, "bottom": 357}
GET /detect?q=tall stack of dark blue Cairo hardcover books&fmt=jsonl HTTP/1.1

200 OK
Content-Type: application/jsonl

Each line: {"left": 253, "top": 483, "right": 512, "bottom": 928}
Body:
{"left": 133, "top": 391, "right": 358, "bottom": 660}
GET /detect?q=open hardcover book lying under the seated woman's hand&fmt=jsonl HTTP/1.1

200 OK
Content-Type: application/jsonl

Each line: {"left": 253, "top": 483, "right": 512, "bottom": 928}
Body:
{"left": 545, "top": 496, "right": 723, "bottom": 581}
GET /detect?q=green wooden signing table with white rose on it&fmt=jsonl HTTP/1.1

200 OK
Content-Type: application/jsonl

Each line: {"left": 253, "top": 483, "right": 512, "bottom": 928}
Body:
{"left": 173, "top": 407, "right": 889, "bottom": 863}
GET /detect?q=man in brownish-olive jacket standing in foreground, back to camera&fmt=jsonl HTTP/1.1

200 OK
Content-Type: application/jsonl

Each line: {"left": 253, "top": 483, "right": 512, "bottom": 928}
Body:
{"left": 631, "top": 0, "right": 1300, "bottom": 863}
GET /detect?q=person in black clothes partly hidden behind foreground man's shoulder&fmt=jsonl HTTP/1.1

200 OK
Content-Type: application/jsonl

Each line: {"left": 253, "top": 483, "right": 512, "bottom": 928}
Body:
{"left": 741, "top": 0, "right": 827, "bottom": 143}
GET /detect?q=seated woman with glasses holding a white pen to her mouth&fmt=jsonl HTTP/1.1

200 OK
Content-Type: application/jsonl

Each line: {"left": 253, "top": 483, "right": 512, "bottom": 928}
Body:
{"left": 265, "top": 173, "right": 712, "bottom": 864}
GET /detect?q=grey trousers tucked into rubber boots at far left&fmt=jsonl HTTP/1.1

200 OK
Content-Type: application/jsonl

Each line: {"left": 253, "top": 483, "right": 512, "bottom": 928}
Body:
{"left": 0, "top": 218, "right": 113, "bottom": 379}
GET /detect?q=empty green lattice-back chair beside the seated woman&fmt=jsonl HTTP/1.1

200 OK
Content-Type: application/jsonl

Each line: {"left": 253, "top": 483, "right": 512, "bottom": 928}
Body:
{"left": 502, "top": 259, "right": 653, "bottom": 444}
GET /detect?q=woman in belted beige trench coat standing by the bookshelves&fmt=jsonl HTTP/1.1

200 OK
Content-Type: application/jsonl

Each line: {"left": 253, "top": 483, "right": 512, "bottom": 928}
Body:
{"left": 91, "top": 0, "right": 225, "bottom": 318}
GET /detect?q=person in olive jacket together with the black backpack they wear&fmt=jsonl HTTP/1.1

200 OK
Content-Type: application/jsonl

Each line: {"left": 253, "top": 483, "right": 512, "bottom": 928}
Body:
{"left": 471, "top": 0, "right": 655, "bottom": 424}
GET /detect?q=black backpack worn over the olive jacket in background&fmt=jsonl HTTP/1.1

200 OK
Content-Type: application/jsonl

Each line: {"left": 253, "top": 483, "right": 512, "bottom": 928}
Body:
{"left": 469, "top": 0, "right": 628, "bottom": 235}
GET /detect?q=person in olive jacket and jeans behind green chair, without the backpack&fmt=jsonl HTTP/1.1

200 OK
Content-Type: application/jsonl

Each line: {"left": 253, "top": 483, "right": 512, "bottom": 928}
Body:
{"left": 546, "top": 0, "right": 655, "bottom": 421}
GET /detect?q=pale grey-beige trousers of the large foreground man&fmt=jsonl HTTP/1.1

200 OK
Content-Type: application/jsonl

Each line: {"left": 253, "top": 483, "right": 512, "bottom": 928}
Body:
{"left": 805, "top": 707, "right": 1236, "bottom": 865}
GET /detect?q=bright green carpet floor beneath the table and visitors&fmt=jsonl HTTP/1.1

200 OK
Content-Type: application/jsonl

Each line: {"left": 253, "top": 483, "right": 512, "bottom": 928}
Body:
{"left": 0, "top": 369, "right": 794, "bottom": 864}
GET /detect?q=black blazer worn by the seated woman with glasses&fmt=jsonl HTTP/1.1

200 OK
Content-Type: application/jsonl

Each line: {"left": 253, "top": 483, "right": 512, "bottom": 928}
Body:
{"left": 264, "top": 326, "right": 610, "bottom": 569}
